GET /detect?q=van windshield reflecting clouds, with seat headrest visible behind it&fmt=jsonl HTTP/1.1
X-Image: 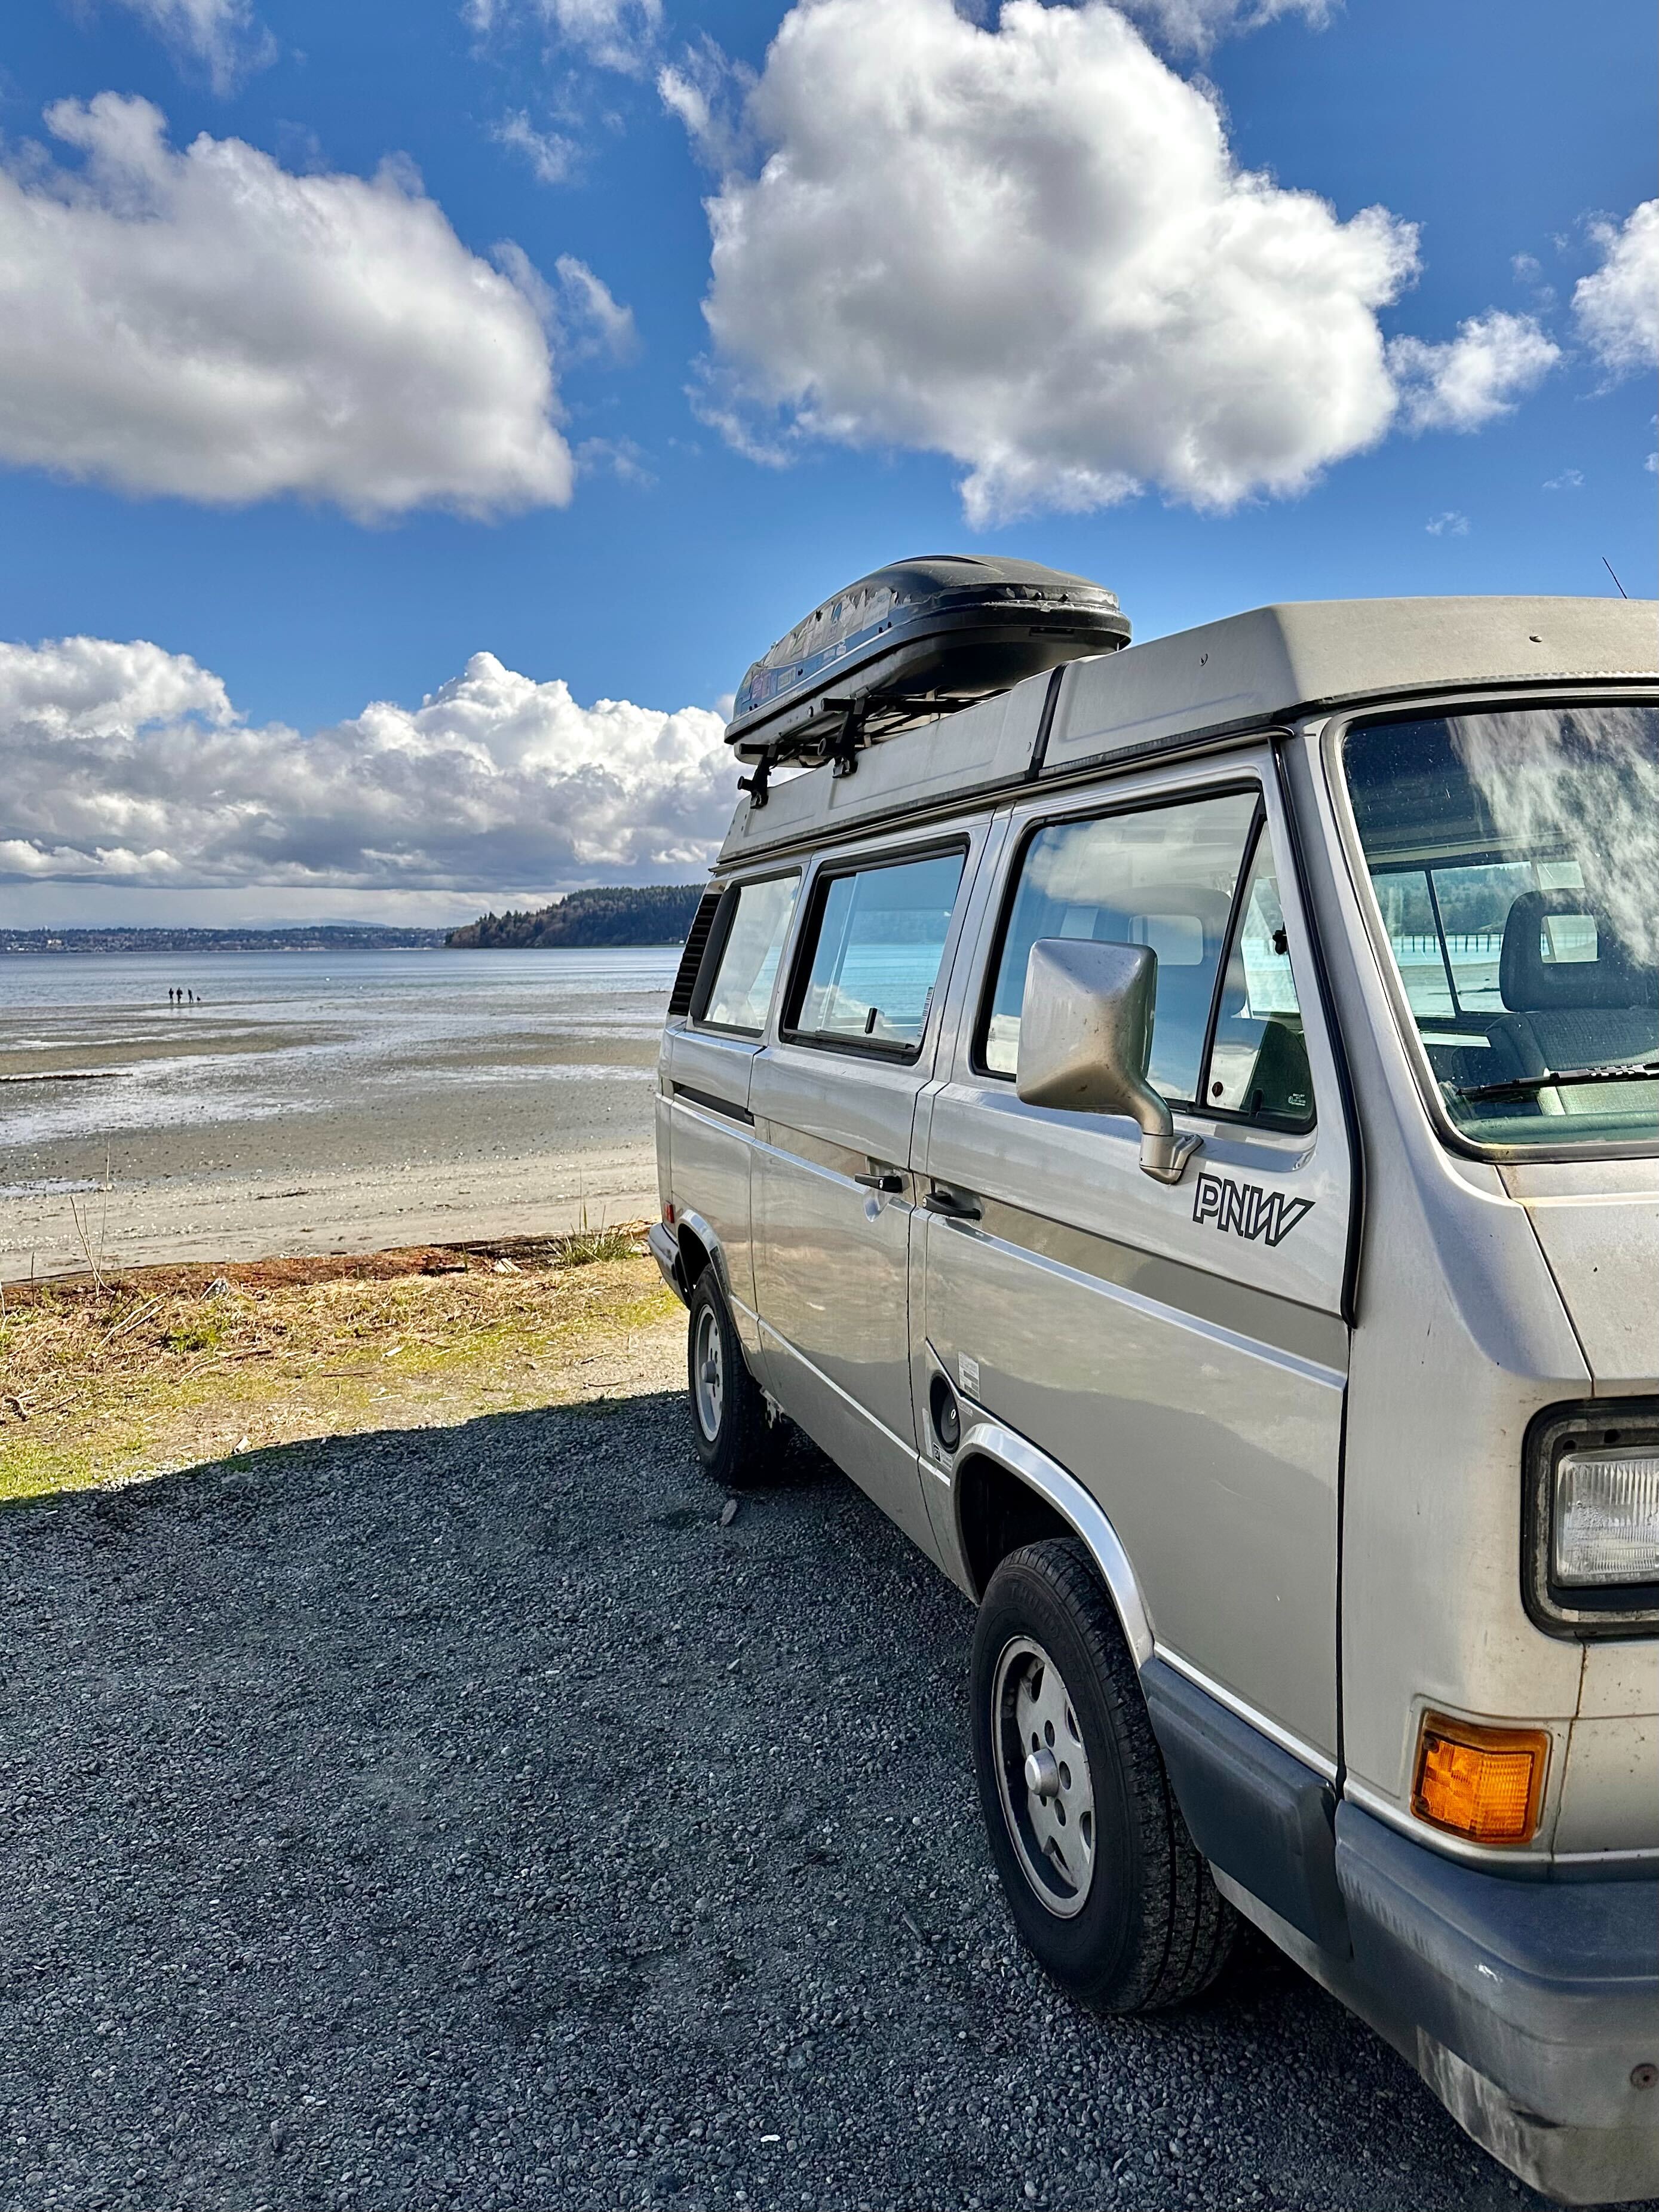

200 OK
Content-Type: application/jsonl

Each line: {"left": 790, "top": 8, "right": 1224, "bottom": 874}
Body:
{"left": 1343, "top": 705, "right": 1659, "bottom": 1151}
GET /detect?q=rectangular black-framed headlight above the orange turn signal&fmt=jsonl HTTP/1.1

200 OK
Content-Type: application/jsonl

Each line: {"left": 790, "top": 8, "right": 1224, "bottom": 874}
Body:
{"left": 1524, "top": 1398, "right": 1659, "bottom": 1637}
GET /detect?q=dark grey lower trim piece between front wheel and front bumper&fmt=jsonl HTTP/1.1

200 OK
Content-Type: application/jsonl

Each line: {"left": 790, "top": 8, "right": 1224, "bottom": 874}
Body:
{"left": 1142, "top": 1655, "right": 1350, "bottom": 1958}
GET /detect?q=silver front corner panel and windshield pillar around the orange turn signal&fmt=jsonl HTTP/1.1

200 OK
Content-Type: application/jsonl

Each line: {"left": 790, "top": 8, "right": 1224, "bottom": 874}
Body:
{"left": 1287, "top": 726, "right": 1589, "bottom": 1831}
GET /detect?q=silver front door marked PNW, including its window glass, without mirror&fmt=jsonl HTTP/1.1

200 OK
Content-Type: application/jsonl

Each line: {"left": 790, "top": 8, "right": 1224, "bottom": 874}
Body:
{"left": 918, "top": 748, "right": 1350, "bottom": 1768}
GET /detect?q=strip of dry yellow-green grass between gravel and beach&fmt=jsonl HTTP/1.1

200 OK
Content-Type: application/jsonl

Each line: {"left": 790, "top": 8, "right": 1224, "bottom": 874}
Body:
{"left": 0, "top": 1228, "right": 679, "bottom": 1500}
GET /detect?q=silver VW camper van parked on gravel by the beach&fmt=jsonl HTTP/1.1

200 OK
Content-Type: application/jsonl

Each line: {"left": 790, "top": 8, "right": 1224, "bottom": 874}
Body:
{"left": 651, "top": 579, "right": 1659, "bottom": 2203}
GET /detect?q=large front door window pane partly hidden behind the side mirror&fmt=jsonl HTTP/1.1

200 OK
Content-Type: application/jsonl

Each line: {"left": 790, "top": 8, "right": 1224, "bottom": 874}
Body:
{"left": 980, "top": 792, "right": 1256, "bottom": 1106}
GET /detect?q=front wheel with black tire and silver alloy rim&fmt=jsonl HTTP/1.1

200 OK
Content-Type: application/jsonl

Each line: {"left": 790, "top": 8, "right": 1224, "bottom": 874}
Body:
{"left": 973, "top": 1539, "right": 1238, "bottom": 2013}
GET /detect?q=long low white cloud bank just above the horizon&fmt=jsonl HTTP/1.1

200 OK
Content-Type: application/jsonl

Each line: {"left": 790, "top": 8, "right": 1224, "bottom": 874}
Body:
{"left": 0, "top": 637, "right": 737, "bottom": 894}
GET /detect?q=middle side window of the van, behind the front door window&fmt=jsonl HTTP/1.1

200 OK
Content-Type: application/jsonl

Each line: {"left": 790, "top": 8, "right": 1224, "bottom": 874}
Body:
{"left": 785, "top": 849, "right": 967, "bottom": 1055}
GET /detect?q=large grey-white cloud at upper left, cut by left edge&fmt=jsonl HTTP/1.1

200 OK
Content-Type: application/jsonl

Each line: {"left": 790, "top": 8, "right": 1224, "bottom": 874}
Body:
{"left": 0, "top": 93, "right": 571, "bottom": 518}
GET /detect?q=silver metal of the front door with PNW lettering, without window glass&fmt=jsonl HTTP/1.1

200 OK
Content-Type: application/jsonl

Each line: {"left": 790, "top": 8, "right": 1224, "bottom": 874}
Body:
{"left": 920, "top": 743, "right": 1350, "bottom": 1768}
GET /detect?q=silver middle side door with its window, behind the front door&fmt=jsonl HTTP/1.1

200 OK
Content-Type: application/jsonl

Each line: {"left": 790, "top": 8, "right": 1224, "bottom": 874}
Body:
{"left": 750, "top": 836, "right": 969, "bottom": 1551}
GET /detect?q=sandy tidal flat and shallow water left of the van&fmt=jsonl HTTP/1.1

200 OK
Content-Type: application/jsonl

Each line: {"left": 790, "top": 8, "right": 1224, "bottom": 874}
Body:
{"left": 0, "top": 949, "right": 677, "bottom": 1281}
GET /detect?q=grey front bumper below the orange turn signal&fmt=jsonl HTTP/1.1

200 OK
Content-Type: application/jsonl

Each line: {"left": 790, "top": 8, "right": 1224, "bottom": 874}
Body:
{"left": 1332, "top": 1805, "right": 1659, "bottom": 2203}
